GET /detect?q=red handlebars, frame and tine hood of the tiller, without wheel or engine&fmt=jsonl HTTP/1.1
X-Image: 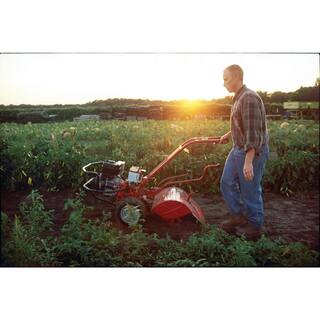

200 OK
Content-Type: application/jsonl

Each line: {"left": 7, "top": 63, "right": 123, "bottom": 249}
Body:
{"left": 83, "top": 137, "right": 220, "bottom": 223}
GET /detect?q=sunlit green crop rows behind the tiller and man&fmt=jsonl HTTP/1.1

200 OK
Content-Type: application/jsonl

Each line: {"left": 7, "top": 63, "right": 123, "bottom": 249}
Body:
{"left": 0, "top": 120, "right": 319, "bottom": 195}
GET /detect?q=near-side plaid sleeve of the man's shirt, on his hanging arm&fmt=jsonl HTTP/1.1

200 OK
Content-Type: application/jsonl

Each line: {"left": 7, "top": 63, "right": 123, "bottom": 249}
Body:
{"left": 241, "top": 95, "right": 262, "bottom": 152}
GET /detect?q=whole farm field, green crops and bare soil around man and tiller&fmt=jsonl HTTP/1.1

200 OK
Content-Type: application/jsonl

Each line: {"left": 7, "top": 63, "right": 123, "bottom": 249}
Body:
{"left": 0, "top": 120, "right": 319, "bottom": 266}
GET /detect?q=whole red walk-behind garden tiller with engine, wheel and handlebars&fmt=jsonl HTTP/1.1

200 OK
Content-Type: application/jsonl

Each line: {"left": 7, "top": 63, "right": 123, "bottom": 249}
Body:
{"left": 82, "top": 137, "right": 220, "bottom": 226}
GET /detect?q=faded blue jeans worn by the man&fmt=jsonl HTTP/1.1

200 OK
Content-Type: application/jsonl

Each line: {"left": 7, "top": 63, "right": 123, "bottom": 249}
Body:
{"left": 220, "top": 145, "right": 269, "bottom": 228}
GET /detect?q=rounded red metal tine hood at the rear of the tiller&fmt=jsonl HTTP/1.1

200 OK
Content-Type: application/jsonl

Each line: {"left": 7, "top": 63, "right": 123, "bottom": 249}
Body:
{"left": 151, "top": 187, "right": 205, "bottom": 224}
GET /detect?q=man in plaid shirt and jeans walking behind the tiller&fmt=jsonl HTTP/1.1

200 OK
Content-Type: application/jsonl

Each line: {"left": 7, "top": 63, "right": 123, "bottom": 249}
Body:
{"left": 220, "top": 65, "right": 269, "bottom": 240}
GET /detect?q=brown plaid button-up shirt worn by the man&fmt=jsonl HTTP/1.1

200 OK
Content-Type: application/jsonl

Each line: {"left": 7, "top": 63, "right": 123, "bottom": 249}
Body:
{"left": 230, "top": 85, "right": 268, "bottom": 154}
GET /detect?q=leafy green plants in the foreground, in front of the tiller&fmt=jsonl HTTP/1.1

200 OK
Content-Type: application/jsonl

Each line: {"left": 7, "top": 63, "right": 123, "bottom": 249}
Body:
{"left": 0, "top": 190, "right": 319, "bottom": 267}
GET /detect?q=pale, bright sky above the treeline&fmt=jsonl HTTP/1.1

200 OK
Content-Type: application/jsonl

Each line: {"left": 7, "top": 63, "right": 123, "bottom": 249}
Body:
{"left": 0, "top": 52, "right": 319, "bottom": 105}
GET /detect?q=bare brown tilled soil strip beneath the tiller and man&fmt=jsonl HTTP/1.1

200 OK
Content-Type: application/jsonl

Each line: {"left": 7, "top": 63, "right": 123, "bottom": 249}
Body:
{"left": 1, "top": 190, "right": 319, "bottom": 251}
